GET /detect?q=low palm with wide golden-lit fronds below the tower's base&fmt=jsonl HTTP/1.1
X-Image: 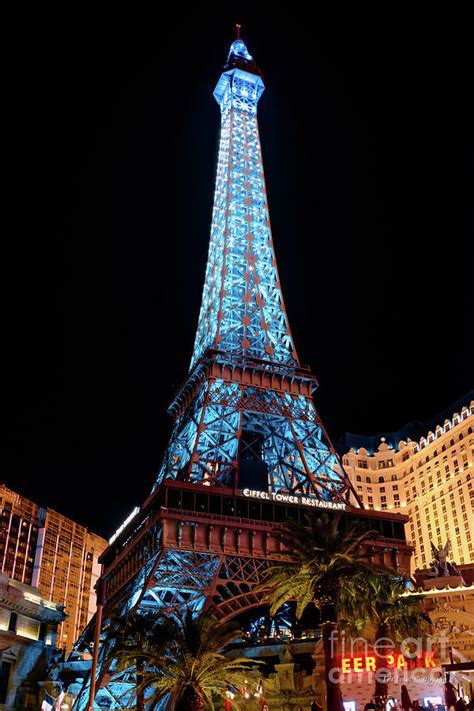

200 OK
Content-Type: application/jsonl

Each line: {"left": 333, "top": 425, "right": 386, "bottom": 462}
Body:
{"left": 132, "top": 610, "right": 259, "bottom": 711}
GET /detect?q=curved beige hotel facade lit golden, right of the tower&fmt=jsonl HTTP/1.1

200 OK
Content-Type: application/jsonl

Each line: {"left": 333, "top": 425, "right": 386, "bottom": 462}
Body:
{"left": 342, "top": 401, "right": 474, "bottom": 569}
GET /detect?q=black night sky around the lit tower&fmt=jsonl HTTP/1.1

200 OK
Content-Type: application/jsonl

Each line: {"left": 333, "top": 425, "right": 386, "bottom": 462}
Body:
{"left": 1, "top": 3, "right": 474, "bottom": 536}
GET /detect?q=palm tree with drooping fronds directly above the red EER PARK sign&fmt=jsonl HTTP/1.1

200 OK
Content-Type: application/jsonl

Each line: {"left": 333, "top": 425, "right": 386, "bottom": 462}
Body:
{"left": 338, "top": 572, "right": 431, "bottom": 708}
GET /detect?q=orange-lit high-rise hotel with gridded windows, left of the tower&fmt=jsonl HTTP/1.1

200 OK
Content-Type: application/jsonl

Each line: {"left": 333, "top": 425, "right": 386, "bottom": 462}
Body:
{"left": 0, "top": 484, "right": 108, "bottom": 651}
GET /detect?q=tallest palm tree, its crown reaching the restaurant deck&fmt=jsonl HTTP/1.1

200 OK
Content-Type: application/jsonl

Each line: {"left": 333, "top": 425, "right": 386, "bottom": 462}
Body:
{"left": 257, "top": 512, "right": 382, "bottom": 711}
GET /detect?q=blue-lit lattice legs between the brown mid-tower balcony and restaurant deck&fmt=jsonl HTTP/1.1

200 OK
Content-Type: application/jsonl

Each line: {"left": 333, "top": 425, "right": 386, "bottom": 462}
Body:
{"left": 157, "top": 379, "right": 348, "bottom": 500}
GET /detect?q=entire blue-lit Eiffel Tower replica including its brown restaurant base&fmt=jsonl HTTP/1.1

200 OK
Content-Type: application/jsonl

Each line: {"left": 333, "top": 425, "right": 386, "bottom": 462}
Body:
{"left": 74, "top": 26, "right": 410, "bottom": 709}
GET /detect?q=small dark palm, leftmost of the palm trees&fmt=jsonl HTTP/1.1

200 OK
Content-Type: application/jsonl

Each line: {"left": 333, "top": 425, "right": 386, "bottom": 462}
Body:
{"left": 101, "top": 611, "right": 161, "bottom": 711}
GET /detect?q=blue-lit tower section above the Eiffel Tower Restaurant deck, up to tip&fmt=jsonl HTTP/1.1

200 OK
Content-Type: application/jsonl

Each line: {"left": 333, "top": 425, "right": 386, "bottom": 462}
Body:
{"left": 157, "top": 37, "right": 350, "bottom": 501}
